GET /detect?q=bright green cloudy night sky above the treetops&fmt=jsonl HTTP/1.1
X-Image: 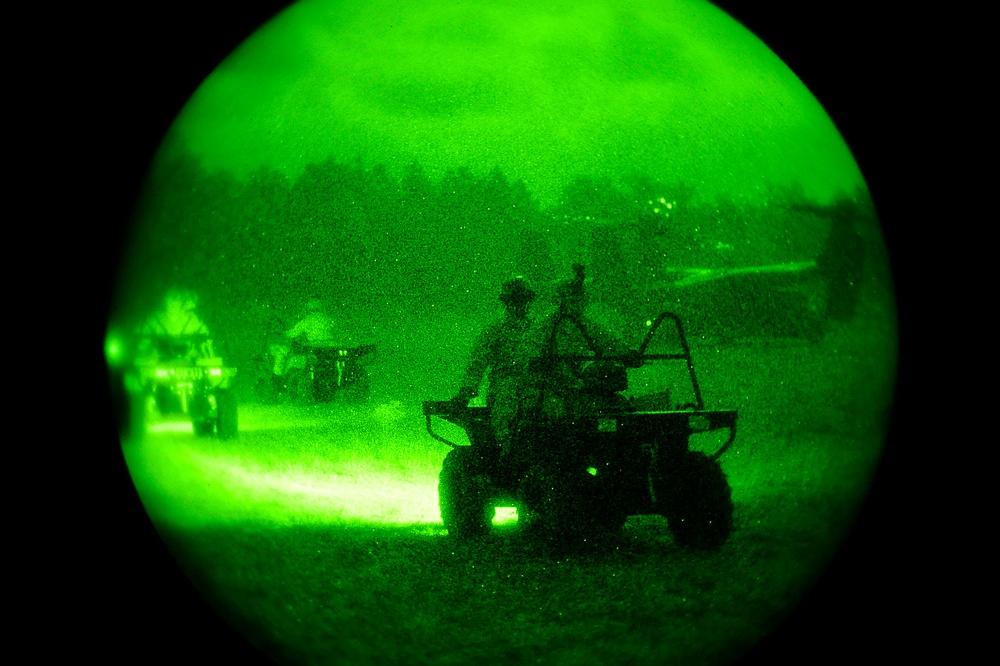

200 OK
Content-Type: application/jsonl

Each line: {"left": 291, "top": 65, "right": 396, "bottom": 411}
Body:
{"left": 165, "top": 0, "right": 862, "bottom": 204}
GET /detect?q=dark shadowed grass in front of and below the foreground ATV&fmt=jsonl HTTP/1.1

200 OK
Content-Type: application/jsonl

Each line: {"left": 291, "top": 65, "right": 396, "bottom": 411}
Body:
{"left": 164, "top": 482, "right": 860, "bottom": 664}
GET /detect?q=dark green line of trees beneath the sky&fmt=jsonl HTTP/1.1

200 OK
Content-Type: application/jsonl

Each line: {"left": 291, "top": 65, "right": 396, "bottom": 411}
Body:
{"left": 115, "top": 147, "right": 877, "bottom": 358}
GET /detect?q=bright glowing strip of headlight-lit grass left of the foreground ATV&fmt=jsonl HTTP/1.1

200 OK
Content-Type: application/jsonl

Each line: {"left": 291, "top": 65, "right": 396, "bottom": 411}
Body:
{"left": 125, "top": 406, "right": 443, "bottom": 528}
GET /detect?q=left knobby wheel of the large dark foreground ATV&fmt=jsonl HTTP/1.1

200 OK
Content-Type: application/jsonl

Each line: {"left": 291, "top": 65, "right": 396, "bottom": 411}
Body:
{"left": 438, "top": 446, "right": 494, "bottom": 536}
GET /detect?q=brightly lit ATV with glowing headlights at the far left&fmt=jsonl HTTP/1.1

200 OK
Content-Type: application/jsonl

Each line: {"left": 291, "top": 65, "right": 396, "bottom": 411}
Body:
{"left": 136, "top": 335, "right": 239, "bottom": 439}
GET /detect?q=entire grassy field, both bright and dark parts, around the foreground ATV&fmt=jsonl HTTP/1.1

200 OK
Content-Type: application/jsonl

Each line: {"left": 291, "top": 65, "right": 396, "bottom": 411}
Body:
{"left": 126, "top": 312, "right": 887, "bottom": 664}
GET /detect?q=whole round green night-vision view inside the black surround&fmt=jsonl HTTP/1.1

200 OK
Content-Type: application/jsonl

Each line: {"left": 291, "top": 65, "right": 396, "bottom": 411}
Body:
{"left": 105, "top": 0, "right": 897, "bottom": 665}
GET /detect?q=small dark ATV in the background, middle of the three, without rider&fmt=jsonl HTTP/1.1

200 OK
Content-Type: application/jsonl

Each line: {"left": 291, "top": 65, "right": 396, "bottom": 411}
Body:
{"left": 257, "top": 340, "right": 375, "bottom": 404}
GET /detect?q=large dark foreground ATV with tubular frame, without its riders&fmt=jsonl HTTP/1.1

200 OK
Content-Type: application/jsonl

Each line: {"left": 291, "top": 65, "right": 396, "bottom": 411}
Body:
{"left": 423, "top": 312, "right": 737, "bottom": 550}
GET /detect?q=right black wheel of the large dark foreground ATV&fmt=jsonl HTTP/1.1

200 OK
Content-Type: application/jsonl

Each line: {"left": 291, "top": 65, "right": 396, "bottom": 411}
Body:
{"left": 652, "top": 451, "right": 733, "bottom": 550}
